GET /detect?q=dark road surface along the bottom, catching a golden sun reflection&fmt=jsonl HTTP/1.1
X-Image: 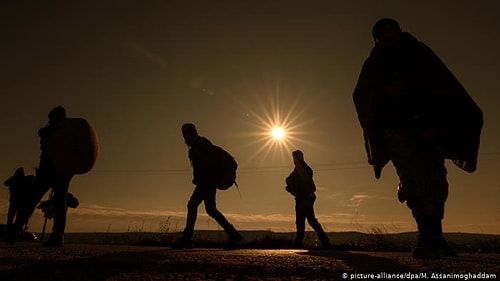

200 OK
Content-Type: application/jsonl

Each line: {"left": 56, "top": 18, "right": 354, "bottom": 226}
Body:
{"left": 0, "top": 243, "right": 500, "bottom": 281}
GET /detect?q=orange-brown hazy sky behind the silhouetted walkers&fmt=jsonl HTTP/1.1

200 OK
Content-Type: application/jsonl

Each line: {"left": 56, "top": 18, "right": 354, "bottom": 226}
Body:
{"left": 0, "top": 0, "right": 500, "bottom": 234}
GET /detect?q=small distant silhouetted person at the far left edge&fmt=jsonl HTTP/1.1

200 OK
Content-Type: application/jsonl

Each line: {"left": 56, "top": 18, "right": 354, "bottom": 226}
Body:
{"left": 4, "top": 167, "right": 33, "bottom": 227}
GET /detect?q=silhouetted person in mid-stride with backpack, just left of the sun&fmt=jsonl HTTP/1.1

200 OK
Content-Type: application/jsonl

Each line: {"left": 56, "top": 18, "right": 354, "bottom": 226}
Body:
{"left": 174, "top": 123, "right": 243, "bottom": 249}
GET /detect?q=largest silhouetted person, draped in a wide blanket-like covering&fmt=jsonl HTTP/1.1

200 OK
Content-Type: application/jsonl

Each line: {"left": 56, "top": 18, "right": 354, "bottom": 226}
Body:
{"left": 353, "top": 18, "right": 483, "bottom": 258}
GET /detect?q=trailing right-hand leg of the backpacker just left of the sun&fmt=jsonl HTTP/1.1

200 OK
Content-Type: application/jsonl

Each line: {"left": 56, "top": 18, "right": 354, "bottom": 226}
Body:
{"left": 204, "top": 188, "right": 243, "bottom": 249}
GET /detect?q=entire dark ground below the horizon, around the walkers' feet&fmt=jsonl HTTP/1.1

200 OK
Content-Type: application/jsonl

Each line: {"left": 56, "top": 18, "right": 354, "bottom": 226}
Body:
{"left": 0, "top": 231, "right": 500, "bottom": 280}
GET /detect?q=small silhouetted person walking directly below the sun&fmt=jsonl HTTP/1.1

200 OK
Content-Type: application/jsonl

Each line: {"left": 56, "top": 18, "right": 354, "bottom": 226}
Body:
{"left": 286, "top": 150, "right": 330, "bottom": 248}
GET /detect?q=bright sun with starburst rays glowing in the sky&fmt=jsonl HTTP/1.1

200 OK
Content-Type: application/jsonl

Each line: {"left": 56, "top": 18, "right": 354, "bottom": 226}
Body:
{"left": 234, "top": 75, "right": 314, "bottom": 165}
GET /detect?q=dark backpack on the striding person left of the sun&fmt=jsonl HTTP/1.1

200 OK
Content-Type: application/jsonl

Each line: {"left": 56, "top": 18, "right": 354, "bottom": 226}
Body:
{"left": 214, "top": 145, "right": 238, "bottom": 190}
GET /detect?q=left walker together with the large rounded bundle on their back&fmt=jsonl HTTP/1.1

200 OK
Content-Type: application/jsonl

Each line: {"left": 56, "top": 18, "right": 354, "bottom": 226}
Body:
{"left": 7, "top": 106, "right": 98, "bottom": 247}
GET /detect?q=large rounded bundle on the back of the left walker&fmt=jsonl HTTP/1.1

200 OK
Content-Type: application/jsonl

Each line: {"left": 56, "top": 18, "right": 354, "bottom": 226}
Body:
{"left": 46, "top": 118, "right": 99, "bottom": 175}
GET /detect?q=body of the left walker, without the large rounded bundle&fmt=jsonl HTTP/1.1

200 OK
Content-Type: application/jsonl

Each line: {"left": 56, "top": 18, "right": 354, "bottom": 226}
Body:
{"left": 7, "top": 106, "right": 73, "bottom": 247}
